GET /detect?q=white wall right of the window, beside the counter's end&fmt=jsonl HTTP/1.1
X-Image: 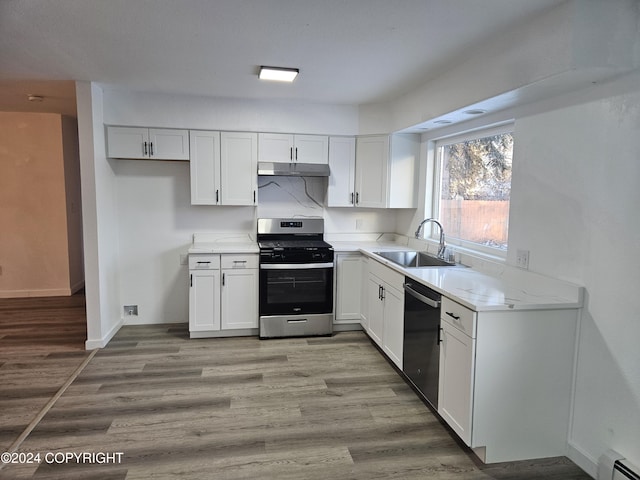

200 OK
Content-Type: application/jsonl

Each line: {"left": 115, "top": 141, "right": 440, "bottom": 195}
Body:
{"left": 509, "top": 73, "right": 640, "bottom": 474}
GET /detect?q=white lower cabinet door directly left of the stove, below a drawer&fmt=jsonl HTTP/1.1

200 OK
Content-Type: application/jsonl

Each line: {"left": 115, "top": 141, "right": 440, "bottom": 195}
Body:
{"left": 222, "top": 269, "right": 258, "bottom": 330}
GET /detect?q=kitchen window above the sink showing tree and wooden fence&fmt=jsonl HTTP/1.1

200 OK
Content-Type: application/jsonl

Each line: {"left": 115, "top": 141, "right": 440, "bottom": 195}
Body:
{"left": 433, "top": 124, "right": 513, "bottom": 256}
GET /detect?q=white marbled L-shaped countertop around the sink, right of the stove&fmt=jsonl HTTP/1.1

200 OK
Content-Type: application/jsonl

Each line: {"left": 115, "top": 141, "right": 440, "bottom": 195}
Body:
{"left": 331, "top": 241, "right": 583, "bottom": 312}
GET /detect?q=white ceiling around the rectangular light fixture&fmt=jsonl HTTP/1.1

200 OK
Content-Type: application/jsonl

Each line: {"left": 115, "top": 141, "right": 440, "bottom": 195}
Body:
{"left": 0, "top": 0, "right": 564, "bottom": 114}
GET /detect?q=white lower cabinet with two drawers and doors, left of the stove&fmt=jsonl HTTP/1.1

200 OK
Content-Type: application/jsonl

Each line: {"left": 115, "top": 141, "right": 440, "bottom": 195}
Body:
{"left": 189, "top": 254, "right": 258, "bottom": 337}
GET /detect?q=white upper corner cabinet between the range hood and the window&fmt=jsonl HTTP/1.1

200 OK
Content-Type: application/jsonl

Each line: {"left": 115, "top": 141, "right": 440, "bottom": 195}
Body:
{"left": 327, "top": 134, "right": 420, "bottom": 208}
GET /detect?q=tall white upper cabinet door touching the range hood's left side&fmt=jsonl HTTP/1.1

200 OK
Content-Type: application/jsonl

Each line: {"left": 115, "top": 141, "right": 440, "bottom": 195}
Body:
{"left": 220, "top": 132, "right": 258, "bottom": 205}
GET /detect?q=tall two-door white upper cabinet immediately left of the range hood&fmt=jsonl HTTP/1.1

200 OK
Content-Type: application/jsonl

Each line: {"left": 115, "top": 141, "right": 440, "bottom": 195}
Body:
{"left": 189, "top": 130, "right": 258, "bottom": 205}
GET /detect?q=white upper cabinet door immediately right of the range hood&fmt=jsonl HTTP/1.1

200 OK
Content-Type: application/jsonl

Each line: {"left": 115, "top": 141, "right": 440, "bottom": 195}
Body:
{"left": 327, "top": 137, "right": 356, "bottom": 207}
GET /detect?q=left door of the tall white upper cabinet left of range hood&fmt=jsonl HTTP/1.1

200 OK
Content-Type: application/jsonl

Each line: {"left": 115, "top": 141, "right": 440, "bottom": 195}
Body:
{"left": 189, "top": 130, "right": 220, "bottom": 205}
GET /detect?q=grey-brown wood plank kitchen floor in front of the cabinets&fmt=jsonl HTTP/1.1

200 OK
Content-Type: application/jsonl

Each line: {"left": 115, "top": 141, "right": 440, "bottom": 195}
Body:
{"left": 0, "top": 312, "right": 590, "bottom": 480}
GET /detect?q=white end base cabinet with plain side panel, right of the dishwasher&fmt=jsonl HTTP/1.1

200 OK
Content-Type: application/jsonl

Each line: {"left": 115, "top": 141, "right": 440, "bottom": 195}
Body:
{"left": 438, "top": 297, "right": 578, "bottom": 463}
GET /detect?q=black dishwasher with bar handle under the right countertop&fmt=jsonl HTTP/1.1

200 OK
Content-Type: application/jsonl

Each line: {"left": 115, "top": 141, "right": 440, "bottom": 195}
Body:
{"left": 402, "top": 277, "right": 441, "bottom": 410}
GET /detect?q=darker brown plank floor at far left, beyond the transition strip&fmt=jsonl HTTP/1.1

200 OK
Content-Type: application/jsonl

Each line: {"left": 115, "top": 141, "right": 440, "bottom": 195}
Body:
{"left": 0, "top": 293, "right": 89, "bottom": 454}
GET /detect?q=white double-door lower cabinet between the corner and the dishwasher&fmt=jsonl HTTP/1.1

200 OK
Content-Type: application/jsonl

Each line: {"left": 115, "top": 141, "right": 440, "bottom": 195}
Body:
{"left": 366, "top": 261, "right": 404, "bottom": 369}
